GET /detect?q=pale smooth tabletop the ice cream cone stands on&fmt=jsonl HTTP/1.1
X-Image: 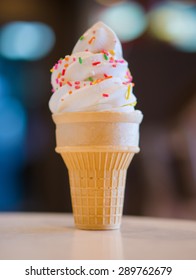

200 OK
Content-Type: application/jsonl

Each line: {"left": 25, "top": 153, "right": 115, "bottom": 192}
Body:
{"left": 0, "top": 213, "right": 196, "bottom": 260}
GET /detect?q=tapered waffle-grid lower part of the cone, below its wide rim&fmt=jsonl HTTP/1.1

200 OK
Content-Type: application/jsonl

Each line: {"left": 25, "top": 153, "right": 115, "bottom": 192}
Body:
{"left": 62, "top": 151, "right": 134, "bottom": 229}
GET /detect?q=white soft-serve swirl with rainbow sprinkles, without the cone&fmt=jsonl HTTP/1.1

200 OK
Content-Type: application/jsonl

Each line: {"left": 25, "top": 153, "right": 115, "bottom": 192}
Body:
{"left": 49, "top": 22, "right": 136, "bottom": 113}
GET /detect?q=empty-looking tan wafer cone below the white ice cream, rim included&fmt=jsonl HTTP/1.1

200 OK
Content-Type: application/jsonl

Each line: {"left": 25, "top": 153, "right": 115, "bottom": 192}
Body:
{"left": 53, "top": 111, "right": 142, "bottom": 229}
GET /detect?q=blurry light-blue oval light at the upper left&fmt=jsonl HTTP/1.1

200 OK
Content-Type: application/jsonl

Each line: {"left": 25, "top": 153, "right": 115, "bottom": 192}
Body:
{"left": 0, "top": 21, "right": 55, "bottom": 60}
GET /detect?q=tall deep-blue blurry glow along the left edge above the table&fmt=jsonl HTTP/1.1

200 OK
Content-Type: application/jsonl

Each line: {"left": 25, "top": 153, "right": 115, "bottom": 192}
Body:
{"left": 0, "top": 79, "right": 27, "bottom": 211}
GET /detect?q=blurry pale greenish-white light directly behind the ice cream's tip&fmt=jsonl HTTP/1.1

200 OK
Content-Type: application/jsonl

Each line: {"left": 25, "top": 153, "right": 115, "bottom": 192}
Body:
{"left": 99, "top": 2, "right": 147, "bottom": 42}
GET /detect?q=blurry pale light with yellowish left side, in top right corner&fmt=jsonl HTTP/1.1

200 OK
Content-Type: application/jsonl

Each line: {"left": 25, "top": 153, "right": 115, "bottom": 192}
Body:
{"left": 149, "top": 1, "right": 196, "bottom": 52}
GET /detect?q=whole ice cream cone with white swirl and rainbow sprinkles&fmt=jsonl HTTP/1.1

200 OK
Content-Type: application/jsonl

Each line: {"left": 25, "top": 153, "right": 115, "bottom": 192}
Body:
{"left": 49, "top": 22, "right": 143, "bottom": 230}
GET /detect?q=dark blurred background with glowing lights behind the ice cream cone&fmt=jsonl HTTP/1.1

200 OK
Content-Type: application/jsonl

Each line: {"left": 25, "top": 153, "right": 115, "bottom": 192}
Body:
{"left": 0, "top": 0, "right": 196, "bottom": 219}
